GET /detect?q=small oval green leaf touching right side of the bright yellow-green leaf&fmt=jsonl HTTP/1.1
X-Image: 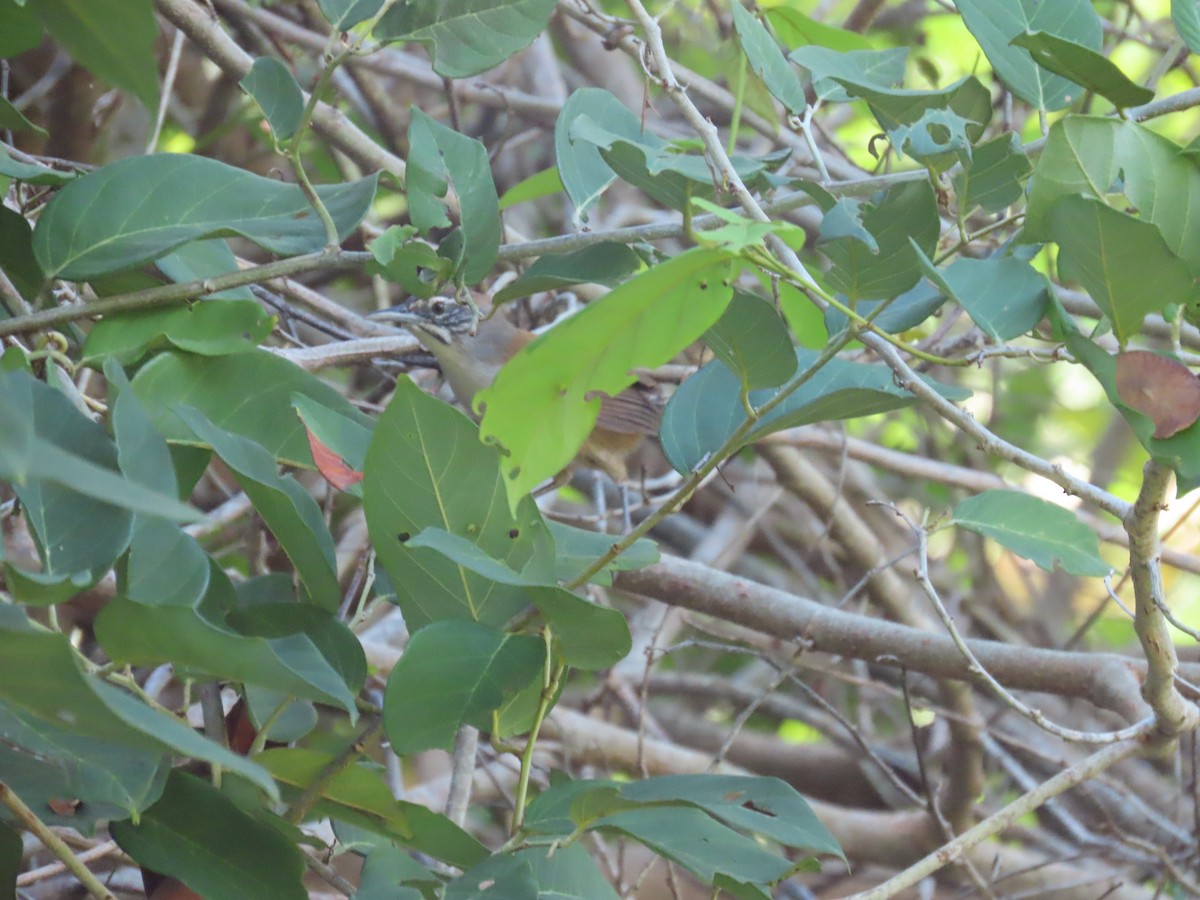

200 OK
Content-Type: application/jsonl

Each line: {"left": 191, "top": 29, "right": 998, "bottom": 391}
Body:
{"left": 704, "top": 290, "right": 796, "bottom": 390}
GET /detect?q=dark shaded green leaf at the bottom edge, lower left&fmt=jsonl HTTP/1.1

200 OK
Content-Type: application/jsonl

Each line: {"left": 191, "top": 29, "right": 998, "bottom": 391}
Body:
{"left": 112, "top": 770, "right": 308, "bottom": 900}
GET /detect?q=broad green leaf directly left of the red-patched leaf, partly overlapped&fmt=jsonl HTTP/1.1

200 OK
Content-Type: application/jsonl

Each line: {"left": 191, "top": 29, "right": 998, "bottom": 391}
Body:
{"left": 133, "top": 349, "right": 371, "bottom": 467}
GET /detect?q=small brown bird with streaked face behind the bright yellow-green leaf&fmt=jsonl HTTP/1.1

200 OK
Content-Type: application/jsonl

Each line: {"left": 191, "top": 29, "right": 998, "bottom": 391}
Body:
{"left": 370, "top": 296, "right": 662, "bottom": 482}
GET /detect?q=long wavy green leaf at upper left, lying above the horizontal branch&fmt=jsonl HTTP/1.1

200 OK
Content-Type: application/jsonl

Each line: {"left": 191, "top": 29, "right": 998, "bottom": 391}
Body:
{"left": 34, "top": 154, "right": 378, "bottom": 281}
